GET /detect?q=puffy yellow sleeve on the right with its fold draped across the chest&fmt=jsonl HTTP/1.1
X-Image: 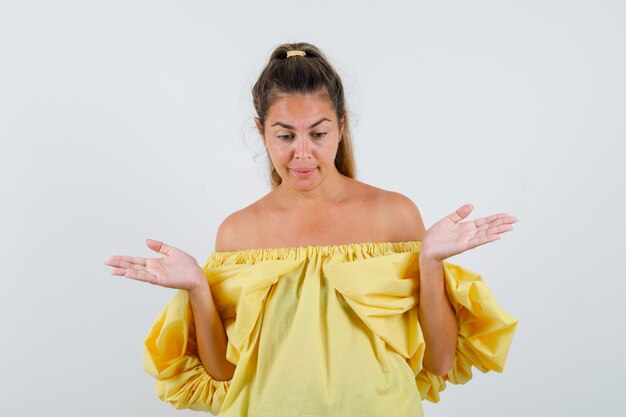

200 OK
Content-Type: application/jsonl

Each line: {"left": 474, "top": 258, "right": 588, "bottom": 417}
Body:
{"left": 324, "top": 250, "right": 517, "bottom": 402}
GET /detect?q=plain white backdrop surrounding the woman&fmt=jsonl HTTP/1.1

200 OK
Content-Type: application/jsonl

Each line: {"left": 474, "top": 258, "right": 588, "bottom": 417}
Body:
{"left": 0, "top": 0, "right": 626, "bottom": 417}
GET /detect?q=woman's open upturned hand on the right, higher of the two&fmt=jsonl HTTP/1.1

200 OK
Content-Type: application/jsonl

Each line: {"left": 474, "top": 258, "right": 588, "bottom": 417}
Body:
{"left": 420, "top": 204, "right": 517, "bottom": 262}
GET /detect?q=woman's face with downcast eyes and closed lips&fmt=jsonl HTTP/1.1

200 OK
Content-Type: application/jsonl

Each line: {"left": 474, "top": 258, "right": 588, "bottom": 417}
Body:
{"left": 256, "top": 94, "right": 345, "bottom": 191}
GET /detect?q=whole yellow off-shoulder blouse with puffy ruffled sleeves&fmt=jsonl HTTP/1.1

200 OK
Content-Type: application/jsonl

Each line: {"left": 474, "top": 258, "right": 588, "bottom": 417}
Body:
{"left": 144, "top": 241, "right": 517, "bottom": 417}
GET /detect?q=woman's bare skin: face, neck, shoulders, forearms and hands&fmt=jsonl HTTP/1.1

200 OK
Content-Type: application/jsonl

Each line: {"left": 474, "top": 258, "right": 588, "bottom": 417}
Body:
{"left": 105, "top": 94, "right": 517, "bottom": 380}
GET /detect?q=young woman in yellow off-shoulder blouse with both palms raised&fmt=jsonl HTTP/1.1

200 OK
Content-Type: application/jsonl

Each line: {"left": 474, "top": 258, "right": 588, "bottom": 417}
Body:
{"left": 106, "top": 43, "right": 517, "bottom": 417}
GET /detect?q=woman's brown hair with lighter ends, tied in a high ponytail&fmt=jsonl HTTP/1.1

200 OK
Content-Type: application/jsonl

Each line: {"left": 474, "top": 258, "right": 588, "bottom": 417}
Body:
{"left": 252, "top": 42, "right": 356, "bottom": 189}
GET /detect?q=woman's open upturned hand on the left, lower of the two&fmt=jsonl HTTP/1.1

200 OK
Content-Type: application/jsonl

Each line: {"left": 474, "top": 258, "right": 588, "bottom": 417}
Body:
{"left": 105, "top": 239, "right": 207, "bottom": 291}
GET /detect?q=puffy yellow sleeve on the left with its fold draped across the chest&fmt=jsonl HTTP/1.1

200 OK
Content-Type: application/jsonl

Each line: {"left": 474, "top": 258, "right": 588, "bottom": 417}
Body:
{"left": 144, "top": 251, "right": 303, "bottom": 415}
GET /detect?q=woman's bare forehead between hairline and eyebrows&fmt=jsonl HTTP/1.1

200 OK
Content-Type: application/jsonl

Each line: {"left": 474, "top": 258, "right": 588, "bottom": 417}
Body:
{"left": 266, "top": 93, "right": 335, "bottom": 127}
